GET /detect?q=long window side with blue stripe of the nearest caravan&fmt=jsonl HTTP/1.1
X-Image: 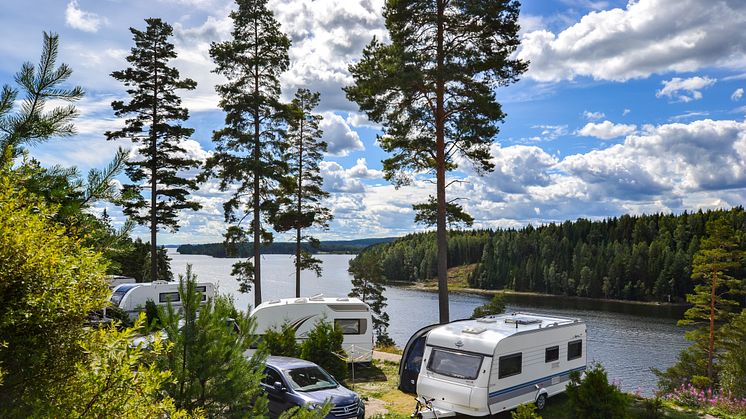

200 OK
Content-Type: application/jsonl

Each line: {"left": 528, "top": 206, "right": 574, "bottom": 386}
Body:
{"left": 489, "top": 323, "right": 586, "bottom": 414}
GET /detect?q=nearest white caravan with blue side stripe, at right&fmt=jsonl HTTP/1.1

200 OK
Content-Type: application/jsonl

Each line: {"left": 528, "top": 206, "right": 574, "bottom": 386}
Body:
{"left": 405, "top": 313, "right": 587, "bottom": 418}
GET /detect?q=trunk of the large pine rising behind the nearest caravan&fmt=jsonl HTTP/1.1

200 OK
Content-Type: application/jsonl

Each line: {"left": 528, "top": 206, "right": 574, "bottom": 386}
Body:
{"left": 435, "top": 0, "right": 450, "bottom": 324}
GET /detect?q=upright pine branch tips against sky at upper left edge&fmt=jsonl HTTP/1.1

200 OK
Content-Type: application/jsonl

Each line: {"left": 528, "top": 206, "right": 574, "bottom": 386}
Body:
{"left": 0, "top": 32, "right": 83, "bottom": 161}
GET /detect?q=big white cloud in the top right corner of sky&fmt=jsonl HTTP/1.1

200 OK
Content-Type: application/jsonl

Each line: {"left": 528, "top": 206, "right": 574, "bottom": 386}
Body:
{"left": 517, "top": 0, "right": 746, "bottom": 81}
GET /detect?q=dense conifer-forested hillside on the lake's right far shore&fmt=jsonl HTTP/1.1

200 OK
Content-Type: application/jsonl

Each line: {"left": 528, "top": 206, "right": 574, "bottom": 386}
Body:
{"left": 352, "top": 207, "right": 746, "bottom": 301}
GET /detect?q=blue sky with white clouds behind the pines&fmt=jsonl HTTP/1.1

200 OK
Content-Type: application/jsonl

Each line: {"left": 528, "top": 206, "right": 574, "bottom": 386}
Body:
{"left": 0, "top": 0, "right": 746, "bottom": 244}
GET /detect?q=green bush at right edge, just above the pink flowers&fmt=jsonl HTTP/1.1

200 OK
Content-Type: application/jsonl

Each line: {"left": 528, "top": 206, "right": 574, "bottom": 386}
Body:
{"left": 718, "top": 309, "right": 746, "bottom": 399}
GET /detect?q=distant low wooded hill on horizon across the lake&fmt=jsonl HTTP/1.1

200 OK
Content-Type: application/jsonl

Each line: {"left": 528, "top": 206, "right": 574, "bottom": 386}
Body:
{"left": 176, "top": 237, "right": 396, "bottom": 258}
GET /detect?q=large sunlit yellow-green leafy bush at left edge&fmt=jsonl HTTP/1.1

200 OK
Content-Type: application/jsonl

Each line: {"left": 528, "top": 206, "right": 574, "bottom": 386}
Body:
{"left": 0, "top": 164, "right": 109, "bottom": 416}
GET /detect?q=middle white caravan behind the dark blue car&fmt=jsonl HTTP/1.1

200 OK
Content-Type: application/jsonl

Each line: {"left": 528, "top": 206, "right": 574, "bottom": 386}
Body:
{"left": 251, "top": 295, "right": 373, "bottom": 362}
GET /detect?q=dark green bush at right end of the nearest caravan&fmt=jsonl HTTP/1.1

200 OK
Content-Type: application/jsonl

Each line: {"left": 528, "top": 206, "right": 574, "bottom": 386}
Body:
{"left": 567, "top": 363, "right": 629, "bottom": 419}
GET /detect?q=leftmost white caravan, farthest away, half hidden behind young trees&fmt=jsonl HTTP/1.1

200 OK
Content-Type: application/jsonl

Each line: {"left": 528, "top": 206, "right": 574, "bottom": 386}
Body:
{"left": 109, "top": 281, "right": 215, "bottom": 319}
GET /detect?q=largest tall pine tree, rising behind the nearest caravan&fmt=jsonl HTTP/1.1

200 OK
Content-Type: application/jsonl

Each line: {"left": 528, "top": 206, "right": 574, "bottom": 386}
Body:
{"left": 345, "top": 0, "right": 527, "bottom": 323}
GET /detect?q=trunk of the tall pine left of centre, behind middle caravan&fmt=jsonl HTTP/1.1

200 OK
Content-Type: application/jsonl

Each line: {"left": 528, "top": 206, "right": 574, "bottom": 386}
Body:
{"left": 252, "top": 22, "right": 262, "bottom": 307}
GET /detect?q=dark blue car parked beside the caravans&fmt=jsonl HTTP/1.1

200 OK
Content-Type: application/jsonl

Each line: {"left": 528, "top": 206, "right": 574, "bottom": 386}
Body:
{"left": 262, "top": 356, "right": 365, "bottom": 419}
